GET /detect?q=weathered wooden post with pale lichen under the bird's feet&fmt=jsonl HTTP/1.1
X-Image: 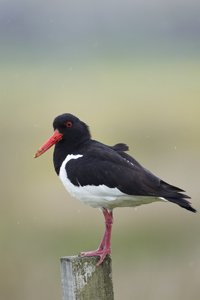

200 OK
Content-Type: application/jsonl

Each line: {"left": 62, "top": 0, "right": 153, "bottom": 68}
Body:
{"left": 60, "top": 256, "right": 114, "bottom": 300}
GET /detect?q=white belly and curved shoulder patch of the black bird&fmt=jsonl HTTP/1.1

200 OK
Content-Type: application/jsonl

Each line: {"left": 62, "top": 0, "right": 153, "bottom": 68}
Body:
{"left": 59, "top": 154, "right": 164, "bottom": 209}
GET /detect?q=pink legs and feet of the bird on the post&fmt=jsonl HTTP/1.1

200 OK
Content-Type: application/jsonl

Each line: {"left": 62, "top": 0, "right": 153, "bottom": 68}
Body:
{"left": 81, "top": 208, "right": 113, "bottom": 266}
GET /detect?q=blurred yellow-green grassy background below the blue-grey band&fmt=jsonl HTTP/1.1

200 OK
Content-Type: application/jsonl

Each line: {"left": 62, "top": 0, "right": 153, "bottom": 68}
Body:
{"left": 0, "top": 57, "right": 200, "bottom": 300}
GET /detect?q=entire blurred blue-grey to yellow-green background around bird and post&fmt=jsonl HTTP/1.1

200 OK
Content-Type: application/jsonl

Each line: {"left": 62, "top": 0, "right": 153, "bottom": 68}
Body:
{"left": 0, "top": 0, "right": 200, "bottom": 300}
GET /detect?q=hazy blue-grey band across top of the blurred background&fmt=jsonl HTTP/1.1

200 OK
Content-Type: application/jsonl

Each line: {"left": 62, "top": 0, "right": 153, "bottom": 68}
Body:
{"left": 0, "top": 0, "right": 200, "bottom": 59}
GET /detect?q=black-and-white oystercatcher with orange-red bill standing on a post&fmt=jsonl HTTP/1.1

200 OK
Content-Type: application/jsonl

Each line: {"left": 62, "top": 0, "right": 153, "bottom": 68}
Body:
{"left": 34, "top": 113, "right": 196, "bottom": 265}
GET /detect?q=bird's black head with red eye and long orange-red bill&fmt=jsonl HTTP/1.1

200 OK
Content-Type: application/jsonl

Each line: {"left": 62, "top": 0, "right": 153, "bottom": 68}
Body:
{"left": 34, "top": 113, "right": 90, "bottom": 157}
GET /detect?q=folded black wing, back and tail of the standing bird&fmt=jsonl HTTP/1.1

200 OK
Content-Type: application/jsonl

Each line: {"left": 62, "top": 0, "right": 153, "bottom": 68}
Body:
{"left": 66, "top": 143, "right": 196, "bottom": 212}
